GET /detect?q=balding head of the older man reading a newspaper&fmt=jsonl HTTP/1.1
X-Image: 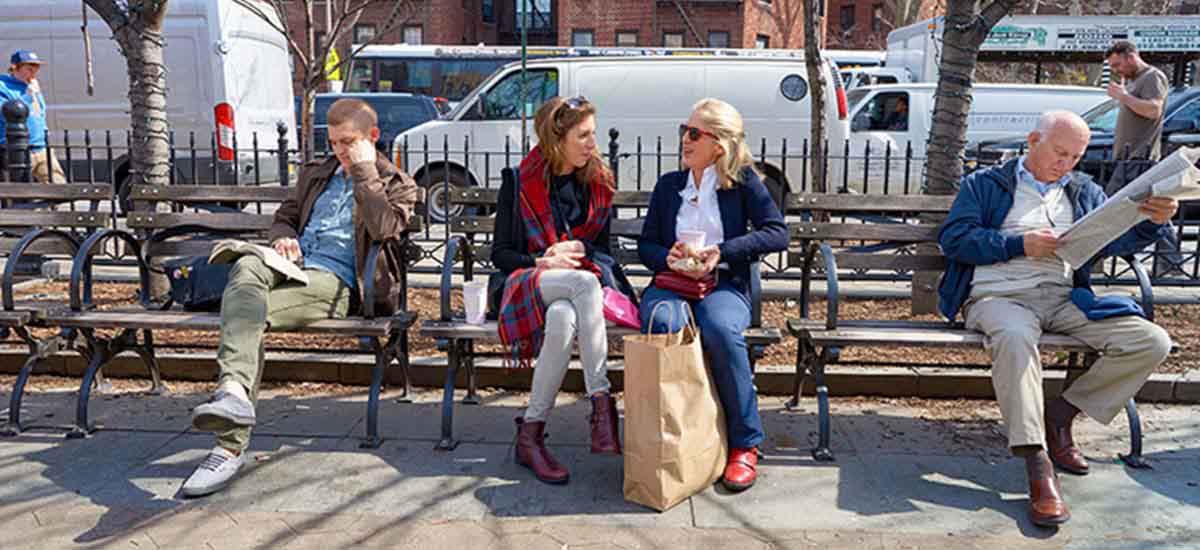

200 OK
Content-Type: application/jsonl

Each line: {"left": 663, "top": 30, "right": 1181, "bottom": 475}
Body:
{"left": 1025, "top": 110, "right": 1092, "bottom": 184}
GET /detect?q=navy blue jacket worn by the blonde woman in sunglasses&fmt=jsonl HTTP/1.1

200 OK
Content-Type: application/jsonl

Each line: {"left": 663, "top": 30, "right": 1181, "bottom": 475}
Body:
{"left": 637, "top": 168, "right": 787, "bottom": 299}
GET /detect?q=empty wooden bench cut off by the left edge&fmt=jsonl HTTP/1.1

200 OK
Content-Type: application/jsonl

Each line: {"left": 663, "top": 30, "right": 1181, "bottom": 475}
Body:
{"left": 0, "top": 183, "right": 113, "bottom": 436}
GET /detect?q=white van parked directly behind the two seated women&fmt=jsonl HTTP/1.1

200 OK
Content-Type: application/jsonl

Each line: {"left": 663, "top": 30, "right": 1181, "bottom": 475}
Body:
{"left": 395, "top": 53, "right": 850, "bottom": 220}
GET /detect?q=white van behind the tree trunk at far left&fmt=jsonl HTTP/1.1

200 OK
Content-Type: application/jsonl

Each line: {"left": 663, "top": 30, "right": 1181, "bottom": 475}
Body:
{"left": 0, "top": 0, "right": 296, "bottom": 186}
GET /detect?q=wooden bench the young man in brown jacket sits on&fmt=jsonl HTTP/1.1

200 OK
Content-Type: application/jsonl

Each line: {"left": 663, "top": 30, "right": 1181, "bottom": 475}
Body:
{"left": 39, "top": 185, "right": 420, "bottom": 448}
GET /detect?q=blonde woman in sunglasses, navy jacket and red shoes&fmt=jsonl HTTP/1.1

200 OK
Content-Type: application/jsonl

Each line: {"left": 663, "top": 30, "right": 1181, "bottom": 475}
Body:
{"left": 637, "top": 98, "right": 787, "bottom": 491}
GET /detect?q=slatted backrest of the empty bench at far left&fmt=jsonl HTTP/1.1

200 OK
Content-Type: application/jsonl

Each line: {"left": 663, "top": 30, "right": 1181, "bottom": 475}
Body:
{"left": 0, "top": 184, "right": 113, "bottom": 255}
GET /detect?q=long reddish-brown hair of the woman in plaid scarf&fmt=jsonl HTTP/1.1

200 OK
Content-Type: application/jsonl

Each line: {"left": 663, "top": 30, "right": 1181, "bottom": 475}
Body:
{"left": 533, "top": 96, "right": 613, "bottom": 187}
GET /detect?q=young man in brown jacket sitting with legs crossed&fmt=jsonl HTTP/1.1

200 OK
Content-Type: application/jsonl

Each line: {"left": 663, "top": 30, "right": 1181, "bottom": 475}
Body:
{"left": 182, "top": 100, "right": 419, "bottom": 496}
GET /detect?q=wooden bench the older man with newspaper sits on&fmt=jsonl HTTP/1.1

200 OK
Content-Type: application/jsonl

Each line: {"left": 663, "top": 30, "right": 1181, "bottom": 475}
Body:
{"left": 787, "top": 193, "right": 1154, "bottom": 467}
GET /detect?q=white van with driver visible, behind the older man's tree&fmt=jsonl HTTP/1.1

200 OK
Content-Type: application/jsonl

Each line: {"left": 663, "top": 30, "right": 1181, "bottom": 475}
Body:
{"left": 830, "top": 83, "right": 1108, "bottom": 193}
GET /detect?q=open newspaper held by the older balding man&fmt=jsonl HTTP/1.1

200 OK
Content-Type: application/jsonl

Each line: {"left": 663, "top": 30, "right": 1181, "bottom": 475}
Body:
{"left": 1055, "top": 148, "right": 1200, "bottom": 269}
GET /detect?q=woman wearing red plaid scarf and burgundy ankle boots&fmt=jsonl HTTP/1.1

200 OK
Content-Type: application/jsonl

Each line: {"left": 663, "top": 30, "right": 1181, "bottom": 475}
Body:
{"left": 492, "top": 97, "right": 634, "bottom": 483}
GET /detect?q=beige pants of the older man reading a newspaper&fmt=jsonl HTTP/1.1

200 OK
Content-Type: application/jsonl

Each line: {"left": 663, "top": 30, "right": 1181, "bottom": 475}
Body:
{"left": 966, "top": 286, "right": 1171, "bottom": 447}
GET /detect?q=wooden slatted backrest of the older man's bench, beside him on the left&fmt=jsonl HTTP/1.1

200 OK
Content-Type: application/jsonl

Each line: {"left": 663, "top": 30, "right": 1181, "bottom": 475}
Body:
{"left": 787, "top": 193, "right": 954, "bottom": 271}
